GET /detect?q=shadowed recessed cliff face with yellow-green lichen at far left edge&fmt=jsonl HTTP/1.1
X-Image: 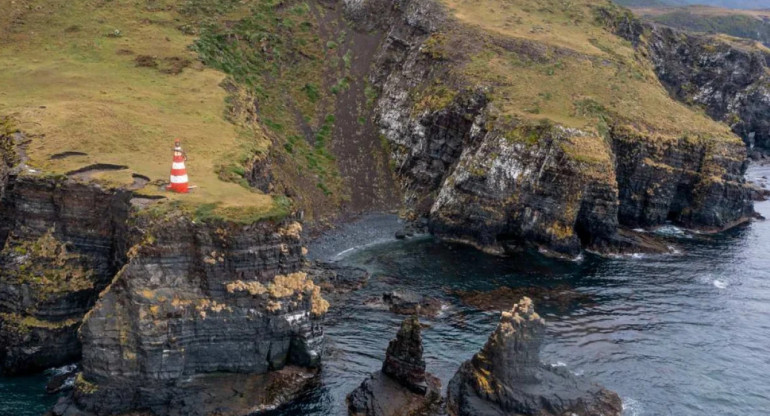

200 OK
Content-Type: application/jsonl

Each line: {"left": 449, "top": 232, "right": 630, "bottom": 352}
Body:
{"left": 0, "top": 177, "right": 128, "bottom": 373}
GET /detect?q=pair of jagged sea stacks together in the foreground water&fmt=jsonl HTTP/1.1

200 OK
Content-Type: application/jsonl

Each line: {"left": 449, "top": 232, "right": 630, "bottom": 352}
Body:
{"left": 347, "top": 297, "right": 623, "bottom": 416}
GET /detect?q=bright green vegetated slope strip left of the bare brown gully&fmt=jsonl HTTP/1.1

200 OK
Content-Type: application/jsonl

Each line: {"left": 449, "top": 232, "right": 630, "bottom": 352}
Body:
{"left": 193, "top": 0, "right": 352, "bottom": 214}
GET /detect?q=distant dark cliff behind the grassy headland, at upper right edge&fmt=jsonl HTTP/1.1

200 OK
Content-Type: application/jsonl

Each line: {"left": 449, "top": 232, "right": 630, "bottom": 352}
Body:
{"left": 597, "top": 7, "right": 770, "bottom": 149}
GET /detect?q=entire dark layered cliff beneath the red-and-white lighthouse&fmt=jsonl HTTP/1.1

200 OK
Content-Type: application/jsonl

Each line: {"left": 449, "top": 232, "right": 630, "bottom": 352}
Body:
{"left": 0, "top": 119, "right": 328, "bottom": 415}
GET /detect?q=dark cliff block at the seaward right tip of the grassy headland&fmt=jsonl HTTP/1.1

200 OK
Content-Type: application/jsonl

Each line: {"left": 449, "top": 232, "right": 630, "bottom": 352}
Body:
{"left": 613, "top": 129, "right": 753, "bottom": 231}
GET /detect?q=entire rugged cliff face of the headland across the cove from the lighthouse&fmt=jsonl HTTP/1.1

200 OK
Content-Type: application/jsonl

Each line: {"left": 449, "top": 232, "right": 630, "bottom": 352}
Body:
{"left": 346, "top": 0, "right": 753, "bottom": 256}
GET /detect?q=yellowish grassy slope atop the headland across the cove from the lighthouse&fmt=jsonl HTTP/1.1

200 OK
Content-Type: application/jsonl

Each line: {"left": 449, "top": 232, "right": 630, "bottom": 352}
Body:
{"left": 432, "top": 0, "right": 740, "bottom": 171}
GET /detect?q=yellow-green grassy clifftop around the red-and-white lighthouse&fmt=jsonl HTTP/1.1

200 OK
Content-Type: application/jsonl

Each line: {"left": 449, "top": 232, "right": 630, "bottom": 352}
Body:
{"left": 0, "top": 0, "right": 276, "bottom": 221}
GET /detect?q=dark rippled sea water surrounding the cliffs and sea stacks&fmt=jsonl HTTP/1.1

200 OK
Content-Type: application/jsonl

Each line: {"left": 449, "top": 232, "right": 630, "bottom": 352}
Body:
{"left": 0, "top": 167, "right": 770, "bottom": 416}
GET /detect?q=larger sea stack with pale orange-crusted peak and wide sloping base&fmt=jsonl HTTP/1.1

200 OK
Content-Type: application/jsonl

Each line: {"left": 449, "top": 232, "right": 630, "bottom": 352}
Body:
{"left": 447, "top": 298, "right": 623, "bottom": 416}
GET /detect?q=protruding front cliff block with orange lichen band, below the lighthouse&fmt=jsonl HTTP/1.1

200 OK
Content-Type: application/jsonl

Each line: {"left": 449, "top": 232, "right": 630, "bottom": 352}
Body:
{"left": 56, "top": 217, "right": 328, "bottom": 415}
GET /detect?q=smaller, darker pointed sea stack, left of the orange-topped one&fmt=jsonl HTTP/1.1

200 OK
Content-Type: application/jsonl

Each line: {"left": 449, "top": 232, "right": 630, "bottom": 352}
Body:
{"left": 348, "top": 315, "right": 441, "bottom": 416}
